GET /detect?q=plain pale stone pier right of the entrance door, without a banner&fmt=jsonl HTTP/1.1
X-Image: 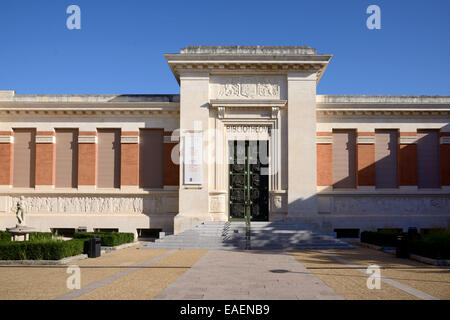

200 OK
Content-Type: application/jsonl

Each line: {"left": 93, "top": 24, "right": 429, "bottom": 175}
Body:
{"left": 287, "top": 72, "right": 317, "bottom": 220}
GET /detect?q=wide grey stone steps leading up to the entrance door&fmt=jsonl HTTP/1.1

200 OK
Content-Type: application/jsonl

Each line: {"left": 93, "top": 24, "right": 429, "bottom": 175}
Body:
{"left": 143, "top": 222, "right": 353, "bottom": 250}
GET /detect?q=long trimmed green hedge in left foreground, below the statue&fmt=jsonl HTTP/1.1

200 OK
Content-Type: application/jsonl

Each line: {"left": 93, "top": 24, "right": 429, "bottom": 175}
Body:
{"left": 0, "top": 239, "right": 86, "bottom": 260}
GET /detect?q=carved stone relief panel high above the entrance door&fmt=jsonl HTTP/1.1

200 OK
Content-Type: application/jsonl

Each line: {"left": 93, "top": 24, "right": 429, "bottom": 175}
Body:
{"left": 210, "top": 76, "right": 286, "bottom": 100}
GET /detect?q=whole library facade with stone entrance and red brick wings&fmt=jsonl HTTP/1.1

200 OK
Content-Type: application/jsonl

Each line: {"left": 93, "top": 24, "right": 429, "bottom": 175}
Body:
{"left": 0, "top": 46, "right": 450, "bottom": 236}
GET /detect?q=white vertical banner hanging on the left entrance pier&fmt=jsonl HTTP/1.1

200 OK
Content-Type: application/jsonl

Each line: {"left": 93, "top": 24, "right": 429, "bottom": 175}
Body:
{"left": 184, "top": 132, "right": 203, "bottom": 184}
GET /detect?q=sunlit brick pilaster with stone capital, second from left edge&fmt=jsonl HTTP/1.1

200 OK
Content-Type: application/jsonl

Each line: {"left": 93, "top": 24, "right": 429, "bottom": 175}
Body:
{"left": 35, "top": 131, "right": 56, "bottom": 188}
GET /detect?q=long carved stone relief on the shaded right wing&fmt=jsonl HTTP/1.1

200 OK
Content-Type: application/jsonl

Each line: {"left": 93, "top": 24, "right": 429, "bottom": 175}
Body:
{"left": 332, "top": 196, "right": 450, "bottom": 215}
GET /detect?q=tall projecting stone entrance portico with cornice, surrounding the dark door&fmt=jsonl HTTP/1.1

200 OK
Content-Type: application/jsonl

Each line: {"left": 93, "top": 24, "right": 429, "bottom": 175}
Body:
{"left": 165, "top": 46, "right": 331, "bottom": 233}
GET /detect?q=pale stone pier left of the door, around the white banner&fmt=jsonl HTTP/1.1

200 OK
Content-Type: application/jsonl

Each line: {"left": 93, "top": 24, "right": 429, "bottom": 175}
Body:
{"left": 174, "top": 72, "right": 211, "bottom": 233}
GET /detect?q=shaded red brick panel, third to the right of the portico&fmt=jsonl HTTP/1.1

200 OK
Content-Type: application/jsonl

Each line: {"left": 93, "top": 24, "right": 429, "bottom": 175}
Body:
{"left": 398, "top": 144, "right": 417, "bottom": 186}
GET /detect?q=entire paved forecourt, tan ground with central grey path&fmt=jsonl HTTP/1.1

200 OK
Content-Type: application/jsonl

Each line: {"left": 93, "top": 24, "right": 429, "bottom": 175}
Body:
{"left": 0, "top": 246, "right": 450, "bottom": 300}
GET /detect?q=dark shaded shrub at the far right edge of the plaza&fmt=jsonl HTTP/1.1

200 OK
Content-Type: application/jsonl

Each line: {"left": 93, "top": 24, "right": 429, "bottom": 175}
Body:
{"left": 408, "top": 231, "right": 450, "bottom": 259}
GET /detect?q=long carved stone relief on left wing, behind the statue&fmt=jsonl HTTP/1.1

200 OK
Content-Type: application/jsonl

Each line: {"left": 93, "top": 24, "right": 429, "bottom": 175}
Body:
{"left": 8, "top": 196, "right": 178, "bottom": 214}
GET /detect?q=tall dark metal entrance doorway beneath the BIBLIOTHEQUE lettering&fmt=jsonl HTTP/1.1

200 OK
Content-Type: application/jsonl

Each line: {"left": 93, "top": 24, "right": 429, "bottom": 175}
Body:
{"left": 228, "top": 140, "right": 269, "bottom": 221}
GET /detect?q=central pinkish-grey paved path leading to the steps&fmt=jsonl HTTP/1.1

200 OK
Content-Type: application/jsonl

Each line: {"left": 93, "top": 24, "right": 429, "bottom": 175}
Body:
{"left": 155, "top": 250, "right": 343, "bottom": 300}
